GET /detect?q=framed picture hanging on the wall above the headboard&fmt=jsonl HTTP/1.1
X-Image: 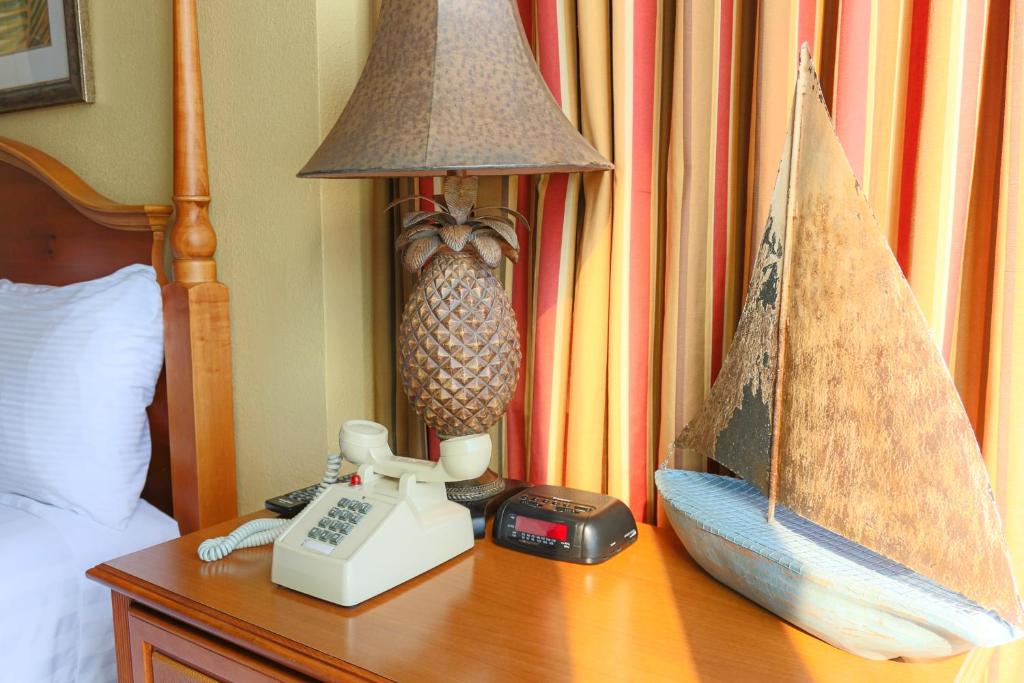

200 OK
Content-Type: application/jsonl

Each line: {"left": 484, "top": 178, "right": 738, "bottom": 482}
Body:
{"left": 0, "top": 0, "right": 92, "bottom": 113}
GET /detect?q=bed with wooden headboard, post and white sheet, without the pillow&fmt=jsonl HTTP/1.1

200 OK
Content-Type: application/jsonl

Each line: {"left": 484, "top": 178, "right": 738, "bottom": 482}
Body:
{"left": 0, "top": 0, "right": 237, "bottom": 681}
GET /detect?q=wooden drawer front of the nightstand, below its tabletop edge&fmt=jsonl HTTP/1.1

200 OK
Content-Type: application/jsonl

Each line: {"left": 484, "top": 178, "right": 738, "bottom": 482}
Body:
{"left": 128, "top": 604, "right": 311, "bottom": 683}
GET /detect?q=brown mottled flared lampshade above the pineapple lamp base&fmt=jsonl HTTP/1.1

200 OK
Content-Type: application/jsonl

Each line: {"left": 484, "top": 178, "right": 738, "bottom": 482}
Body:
{"left": 299, "top": 0, "right": 612, "bottom": 178}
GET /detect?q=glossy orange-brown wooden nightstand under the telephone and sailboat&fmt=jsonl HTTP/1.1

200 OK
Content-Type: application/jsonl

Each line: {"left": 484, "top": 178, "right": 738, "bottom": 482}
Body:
{"left": 89, "top": 515, "right": 991, "bottom": 682}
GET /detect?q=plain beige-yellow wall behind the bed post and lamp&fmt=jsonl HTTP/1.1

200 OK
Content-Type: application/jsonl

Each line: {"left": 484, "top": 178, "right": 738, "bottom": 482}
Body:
{"left": 0, "top": 0, "right": 373, "bottom": 510}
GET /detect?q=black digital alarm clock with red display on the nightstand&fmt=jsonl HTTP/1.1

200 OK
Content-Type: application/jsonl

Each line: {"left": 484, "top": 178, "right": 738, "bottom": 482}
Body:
{"left": 494, "top": 486, "right": 637, "bottom": 564}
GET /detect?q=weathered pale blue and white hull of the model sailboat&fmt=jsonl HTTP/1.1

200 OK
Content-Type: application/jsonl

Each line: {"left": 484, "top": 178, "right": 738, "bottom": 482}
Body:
{"left": 655, "top": 469, "right": 1022, "bottom": 660}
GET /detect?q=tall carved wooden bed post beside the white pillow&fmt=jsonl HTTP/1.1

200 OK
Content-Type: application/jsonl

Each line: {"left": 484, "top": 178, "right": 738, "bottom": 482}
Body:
{"left": 164, "top": 0, "right": 238, "bottom": 533}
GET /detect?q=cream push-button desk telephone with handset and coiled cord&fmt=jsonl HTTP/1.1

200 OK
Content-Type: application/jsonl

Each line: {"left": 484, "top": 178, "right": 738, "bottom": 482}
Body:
{"left": 200, "top": 420, "right": 490, "bottom": 606}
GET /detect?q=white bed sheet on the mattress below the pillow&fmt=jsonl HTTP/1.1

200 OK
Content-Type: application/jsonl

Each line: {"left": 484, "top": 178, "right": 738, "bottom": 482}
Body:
{"left": 0, "top": 494, "right": 178, "bottom": 683}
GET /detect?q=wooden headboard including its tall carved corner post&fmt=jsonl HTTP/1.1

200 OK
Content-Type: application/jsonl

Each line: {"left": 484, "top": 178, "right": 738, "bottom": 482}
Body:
{"left": 0, "top": 0, "right": 238, "bottom": 533}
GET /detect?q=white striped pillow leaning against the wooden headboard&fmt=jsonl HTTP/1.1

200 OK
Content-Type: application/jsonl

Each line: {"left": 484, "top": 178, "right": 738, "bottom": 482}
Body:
{"left": 0, "top": 265, "right": 164, "bottom": 528}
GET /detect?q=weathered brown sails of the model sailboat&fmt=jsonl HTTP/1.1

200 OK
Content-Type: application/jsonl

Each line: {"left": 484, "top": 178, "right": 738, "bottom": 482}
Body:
{"left": 677, "top": 48, "right": 1024, "bottom": 624}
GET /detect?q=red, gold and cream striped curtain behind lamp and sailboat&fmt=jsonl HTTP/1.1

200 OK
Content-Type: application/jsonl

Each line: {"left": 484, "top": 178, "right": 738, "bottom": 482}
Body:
{"left": 378, "top": 0, "right": 1024, "bottom": 680}
